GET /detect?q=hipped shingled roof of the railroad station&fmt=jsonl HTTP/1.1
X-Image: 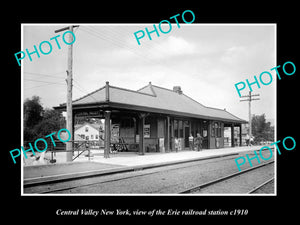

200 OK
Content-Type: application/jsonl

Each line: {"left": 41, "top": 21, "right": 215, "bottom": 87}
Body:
{"left": 54, "top": 82, "right": 247, "bottom": 123}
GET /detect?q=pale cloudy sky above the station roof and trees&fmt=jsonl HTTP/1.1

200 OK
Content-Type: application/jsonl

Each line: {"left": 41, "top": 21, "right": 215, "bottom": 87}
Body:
{"left": 22, "top": 23, "right": 277, "bottom": 120}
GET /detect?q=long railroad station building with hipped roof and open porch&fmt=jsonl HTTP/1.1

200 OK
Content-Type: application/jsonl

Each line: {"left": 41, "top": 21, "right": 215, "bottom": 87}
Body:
{"left": 54, "top": 82, "right": 247, "bottom": 157}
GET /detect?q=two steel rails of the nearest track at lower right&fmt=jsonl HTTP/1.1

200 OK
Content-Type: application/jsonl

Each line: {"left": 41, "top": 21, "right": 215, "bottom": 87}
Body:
{"left": 178, "top": 160, "right": 274, "bottom": 194}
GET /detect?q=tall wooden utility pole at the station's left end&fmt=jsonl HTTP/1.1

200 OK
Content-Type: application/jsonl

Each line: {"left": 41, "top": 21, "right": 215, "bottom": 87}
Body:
{"left": 54, "top": 26, "right": 79, "bottom": 162}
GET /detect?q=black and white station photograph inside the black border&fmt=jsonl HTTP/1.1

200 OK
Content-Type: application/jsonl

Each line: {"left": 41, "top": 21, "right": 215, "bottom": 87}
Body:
{"left": 19, "top": 23, "right": 276, "bottom": 195}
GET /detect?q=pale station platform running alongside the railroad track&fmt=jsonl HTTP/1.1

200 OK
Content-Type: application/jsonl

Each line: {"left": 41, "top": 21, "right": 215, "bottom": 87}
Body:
{"left": 22, "top": 146, "right": 270, "bottom": 185}
